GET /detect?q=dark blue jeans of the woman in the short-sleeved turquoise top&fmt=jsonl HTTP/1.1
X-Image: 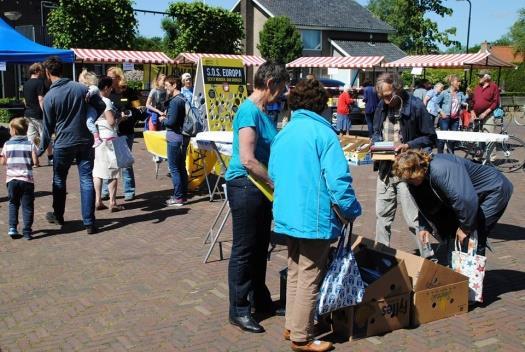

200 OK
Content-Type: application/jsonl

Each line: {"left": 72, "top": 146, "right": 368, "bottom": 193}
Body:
{"left": 226, "top": 177, "right": 273, "bottom": 317}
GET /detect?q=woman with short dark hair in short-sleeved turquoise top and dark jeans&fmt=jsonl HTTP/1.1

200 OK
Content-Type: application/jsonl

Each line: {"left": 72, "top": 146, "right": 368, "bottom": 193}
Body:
{"left": 225, "top": 61, "right": 289, "bottom": 333}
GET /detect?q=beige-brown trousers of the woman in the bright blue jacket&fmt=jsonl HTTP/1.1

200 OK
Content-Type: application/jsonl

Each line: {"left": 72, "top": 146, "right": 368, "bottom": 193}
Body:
{"left": 285, "top": 236, "right": 331, "bottom": 342}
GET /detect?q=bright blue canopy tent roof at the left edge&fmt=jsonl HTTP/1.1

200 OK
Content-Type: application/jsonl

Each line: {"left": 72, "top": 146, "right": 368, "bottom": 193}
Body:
{"left": 0, "top": 18, "right": 75, "bottom": 97}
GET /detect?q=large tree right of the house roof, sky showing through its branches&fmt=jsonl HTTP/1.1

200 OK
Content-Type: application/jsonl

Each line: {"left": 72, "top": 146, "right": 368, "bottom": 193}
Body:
{"left": 368, "top": 0, "right": 459, "bottom": 54}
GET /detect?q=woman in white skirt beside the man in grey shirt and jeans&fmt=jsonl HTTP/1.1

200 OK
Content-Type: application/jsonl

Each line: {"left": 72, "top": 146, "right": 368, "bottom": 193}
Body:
{"left": 93, "top": 76, "right": 124, "bottom": 212}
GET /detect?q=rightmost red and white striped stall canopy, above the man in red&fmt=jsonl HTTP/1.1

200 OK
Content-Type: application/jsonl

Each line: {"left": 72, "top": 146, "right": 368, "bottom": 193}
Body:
{"left": 384, "top": 51, "right": 514, "bottom": 68}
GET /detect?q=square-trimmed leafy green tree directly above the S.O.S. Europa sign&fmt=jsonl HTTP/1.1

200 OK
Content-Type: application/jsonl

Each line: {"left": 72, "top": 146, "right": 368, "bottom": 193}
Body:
{"left": 162, "top": 2, "right": 244, "bottom": 55}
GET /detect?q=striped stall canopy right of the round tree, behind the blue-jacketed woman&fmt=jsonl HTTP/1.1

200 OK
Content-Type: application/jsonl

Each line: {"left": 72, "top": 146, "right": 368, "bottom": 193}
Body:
{"left": 286, "top": 56, "right": 384, "bottom": 68}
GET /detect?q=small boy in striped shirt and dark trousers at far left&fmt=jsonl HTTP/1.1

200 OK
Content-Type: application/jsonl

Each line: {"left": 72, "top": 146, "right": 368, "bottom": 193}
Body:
{"left": 0, "top": 117, "right": 38, "bottom": 240}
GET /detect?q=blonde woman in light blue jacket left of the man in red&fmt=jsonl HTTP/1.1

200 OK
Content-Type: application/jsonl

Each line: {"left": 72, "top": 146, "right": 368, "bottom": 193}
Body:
{"left": 436, "top": 75, "right": 467, "bottom": 153}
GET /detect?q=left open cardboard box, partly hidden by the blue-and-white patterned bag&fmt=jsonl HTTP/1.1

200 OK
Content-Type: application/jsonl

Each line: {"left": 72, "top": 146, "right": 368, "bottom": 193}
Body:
{"left": 332, "top": 247, "right": 412, "bottom": 339}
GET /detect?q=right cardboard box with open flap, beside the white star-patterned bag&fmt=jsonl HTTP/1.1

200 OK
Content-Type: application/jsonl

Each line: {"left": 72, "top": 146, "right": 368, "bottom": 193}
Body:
{"left": 352, "top": 237, "right": 468, "bottom": 326}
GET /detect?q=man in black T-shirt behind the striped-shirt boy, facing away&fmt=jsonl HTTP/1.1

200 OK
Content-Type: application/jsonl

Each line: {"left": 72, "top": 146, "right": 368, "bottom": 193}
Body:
{"left": 24, "top": 63, "right": 53, "bottom": 165}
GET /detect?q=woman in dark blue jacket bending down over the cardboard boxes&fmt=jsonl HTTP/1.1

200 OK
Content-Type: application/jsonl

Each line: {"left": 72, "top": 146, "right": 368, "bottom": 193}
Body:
{"left": 394, "top": 150, "right": 513, "bottom": 265}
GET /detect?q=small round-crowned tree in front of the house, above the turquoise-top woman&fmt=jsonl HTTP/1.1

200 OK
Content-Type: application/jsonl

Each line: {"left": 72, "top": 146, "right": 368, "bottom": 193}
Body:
{"left": 257, "top": 16, "right": 303, "bottom": 63}
